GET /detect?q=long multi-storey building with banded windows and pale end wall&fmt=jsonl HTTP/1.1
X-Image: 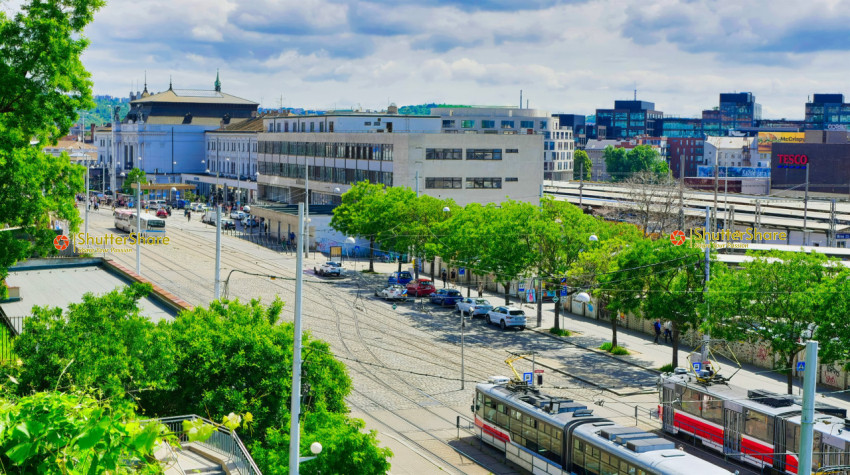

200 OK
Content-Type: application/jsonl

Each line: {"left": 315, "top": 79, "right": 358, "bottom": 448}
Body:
{"left": 253, "top": 113, "right": 543, "bottom": 209}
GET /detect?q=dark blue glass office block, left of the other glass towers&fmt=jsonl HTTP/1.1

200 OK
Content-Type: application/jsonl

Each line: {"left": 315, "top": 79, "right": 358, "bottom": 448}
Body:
{"left": 595, "top": 100, "right": 664, "bottom": 140}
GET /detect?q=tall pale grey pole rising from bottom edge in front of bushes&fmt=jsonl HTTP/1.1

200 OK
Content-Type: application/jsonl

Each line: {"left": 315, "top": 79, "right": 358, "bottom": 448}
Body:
{"left": 289, "top": 203, "right": 305, "bottom": 475}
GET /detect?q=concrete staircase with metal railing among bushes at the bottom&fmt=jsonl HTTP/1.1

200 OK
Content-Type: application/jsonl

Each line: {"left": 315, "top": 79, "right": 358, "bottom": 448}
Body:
{"left": 148, "top": 415, "right": 262, "bottom": 475}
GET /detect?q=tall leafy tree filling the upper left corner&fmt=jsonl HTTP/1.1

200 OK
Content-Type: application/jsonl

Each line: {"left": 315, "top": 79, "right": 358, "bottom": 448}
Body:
{"left": 0, "top": 0, "right": 104, "bottom": 294}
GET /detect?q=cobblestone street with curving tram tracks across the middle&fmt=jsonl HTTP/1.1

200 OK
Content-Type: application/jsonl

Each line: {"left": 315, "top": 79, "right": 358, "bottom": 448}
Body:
{"left": 78, "top": 210, "right": 724, "bottom": 474}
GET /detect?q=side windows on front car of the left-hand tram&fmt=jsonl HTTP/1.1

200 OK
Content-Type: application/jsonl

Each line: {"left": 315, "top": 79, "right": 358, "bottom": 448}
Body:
{"left": 475, "top": 392, "right": 564, "bottom": 464}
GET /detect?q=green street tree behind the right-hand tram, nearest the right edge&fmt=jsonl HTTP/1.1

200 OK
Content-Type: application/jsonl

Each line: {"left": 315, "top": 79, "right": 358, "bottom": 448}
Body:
{"left": 705, "top": 252, "right": 846, "bottom": 394}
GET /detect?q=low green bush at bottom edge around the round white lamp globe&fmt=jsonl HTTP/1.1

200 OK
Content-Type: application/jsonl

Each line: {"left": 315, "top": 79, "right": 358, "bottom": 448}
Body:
{"left": 251, "top": 411, "right": 393, "bottom": 475}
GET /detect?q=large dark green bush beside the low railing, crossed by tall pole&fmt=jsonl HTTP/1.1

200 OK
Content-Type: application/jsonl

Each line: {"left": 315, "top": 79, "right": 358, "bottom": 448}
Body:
{"left": 157, "top": 300, "right": 351, "bottom": 439}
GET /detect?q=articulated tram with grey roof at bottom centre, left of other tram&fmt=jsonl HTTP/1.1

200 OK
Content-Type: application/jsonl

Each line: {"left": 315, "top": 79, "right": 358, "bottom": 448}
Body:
{"left": 471, "top": 376, "right": 731, "bottom": 475}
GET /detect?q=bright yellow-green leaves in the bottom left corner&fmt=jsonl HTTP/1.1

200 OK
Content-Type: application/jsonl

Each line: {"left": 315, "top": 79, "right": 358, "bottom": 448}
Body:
{"left": 0, "top": 392, "right": 167, "bottom": 475}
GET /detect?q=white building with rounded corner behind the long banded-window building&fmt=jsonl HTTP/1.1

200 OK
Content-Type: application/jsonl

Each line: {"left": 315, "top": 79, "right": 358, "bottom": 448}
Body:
{"left": 431, "top": 107, "right": 575, "bottom": 180}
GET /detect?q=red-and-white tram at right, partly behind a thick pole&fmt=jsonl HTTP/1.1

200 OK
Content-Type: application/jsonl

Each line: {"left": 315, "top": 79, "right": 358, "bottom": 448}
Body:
{"left": 659, "top": 368, "right": 850, "bottom": 475}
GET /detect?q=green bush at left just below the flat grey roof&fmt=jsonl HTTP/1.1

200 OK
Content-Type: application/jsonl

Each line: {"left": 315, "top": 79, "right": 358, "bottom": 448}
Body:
{"left": 14, "top": 284, "right": 175, "bottom": 406}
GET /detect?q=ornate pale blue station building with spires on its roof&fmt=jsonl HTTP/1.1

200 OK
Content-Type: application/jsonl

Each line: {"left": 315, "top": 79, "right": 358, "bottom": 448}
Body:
{"left": 95, "top": 76, "right": 259, "bottom": 192}
